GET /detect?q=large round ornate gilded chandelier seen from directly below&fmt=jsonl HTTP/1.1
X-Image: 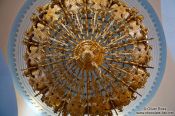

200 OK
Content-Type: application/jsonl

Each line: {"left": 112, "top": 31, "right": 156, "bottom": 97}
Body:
{"left": 23, "top": 0, "right": 153, "bottom": 116}
